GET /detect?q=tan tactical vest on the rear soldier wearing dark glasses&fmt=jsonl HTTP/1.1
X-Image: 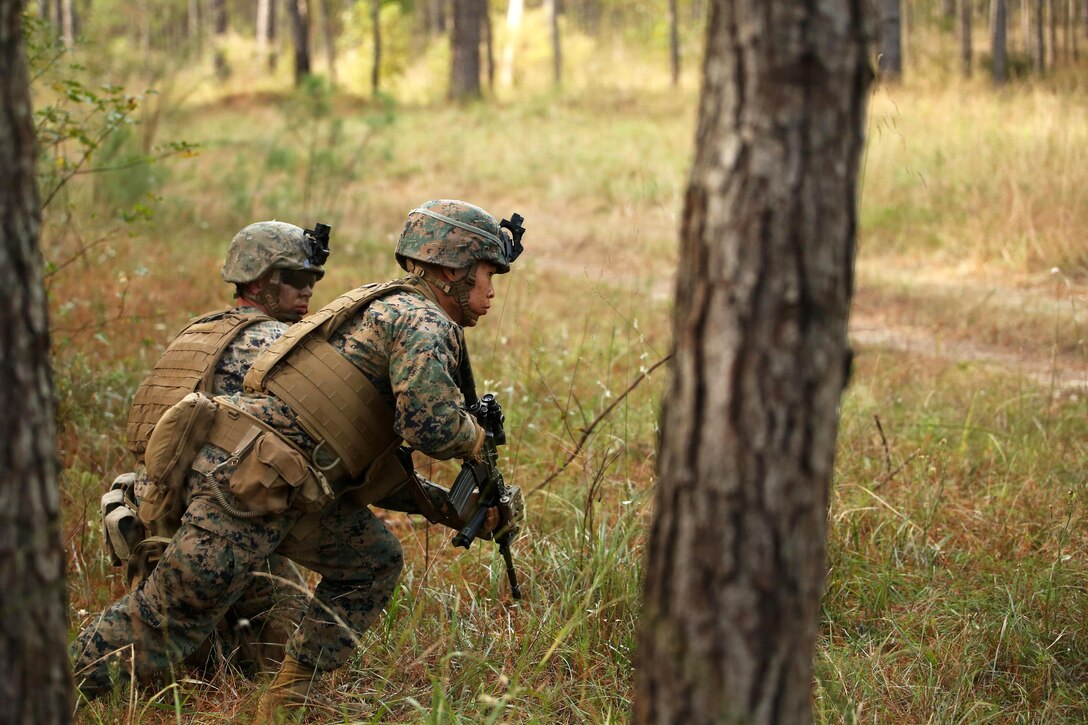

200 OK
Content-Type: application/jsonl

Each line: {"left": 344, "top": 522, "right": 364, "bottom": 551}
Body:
{"left": 126, "top": 310, "right": 272, "bottom": 458}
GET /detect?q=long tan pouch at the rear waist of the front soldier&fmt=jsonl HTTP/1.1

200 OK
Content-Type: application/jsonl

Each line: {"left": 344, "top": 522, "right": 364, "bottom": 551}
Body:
{"left": 139, "top": 393, "right": 217, "bottom": 526}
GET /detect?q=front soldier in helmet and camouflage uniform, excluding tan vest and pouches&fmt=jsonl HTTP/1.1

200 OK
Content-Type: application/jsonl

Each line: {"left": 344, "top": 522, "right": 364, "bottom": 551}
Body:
{"left": 75, "top": 200, "right": 520, "bottom": 717}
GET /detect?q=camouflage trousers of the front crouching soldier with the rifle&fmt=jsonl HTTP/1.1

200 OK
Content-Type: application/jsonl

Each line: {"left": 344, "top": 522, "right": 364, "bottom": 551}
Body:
{"left": 72, "top": 446, "right": 403, "bottom": 696}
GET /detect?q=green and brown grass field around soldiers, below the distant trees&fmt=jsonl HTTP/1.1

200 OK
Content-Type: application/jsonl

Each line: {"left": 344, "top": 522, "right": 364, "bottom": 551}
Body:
{"left": 45, "top": 40, "right": 1088, "bottom": 723}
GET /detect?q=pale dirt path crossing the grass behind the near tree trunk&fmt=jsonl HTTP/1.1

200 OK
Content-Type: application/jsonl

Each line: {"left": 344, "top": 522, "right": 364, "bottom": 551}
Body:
{"left": 537, "top": 256, "right": 1088, "bottom": 394}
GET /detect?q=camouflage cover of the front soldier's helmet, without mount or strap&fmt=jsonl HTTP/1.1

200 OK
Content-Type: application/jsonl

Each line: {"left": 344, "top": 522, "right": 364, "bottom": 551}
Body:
{"left": 396, "top": 199, "right": 510, "bottom": 273}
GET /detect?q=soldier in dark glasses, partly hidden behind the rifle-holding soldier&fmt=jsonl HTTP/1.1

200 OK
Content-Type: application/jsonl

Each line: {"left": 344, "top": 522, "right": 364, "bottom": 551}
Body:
{"left": 96, "top": 222, "right": 326, "bottom": 672}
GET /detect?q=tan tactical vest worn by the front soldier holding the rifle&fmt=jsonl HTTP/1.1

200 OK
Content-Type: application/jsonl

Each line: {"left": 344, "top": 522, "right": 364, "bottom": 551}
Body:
{"left": 243, "top": 280, "right": 420, "bottom": 488}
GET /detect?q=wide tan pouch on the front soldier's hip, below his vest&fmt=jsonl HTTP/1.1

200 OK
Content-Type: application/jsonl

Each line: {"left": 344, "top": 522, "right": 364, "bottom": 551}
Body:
{"left": 230, "top": 432, "right": 331, "bottom": 515}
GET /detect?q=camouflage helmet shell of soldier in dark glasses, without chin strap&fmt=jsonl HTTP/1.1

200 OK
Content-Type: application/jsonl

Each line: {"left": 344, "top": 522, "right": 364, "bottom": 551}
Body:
{"left": 220, "top": 221, "right": 325, "bottom": 284}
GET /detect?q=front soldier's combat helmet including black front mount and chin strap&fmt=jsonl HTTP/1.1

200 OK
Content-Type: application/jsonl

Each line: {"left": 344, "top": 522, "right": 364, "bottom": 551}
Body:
{"left": 396, "top": 199, "right": 524, "bottom": 327}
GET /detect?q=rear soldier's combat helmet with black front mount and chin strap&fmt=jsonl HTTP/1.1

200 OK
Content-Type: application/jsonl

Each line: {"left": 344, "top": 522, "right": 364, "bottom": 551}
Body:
{"left": 220, "top": 221, "right": 330, "bottom": 322}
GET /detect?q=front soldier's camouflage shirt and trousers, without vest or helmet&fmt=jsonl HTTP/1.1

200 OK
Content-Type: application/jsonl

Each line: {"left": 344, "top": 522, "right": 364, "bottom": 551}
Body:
{"left": 75, "top": 199, "right": 522, "bottom": 692}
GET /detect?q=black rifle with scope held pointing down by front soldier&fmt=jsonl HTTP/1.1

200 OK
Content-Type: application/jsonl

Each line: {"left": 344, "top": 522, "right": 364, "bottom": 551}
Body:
{"left": 449, "top": 393, "right": 523, "bottom": 599}
